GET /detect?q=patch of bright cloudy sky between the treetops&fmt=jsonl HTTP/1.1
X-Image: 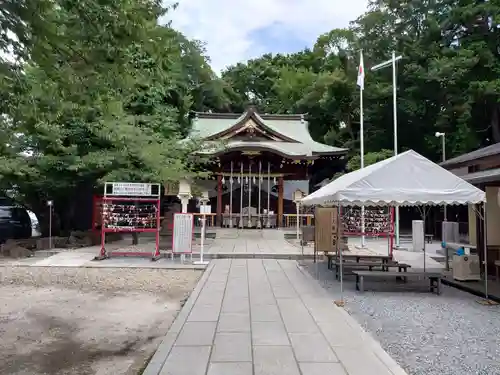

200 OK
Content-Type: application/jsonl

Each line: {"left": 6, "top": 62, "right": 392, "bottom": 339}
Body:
{"left": 168, "top": 0, "right": 368, "bottom": 71}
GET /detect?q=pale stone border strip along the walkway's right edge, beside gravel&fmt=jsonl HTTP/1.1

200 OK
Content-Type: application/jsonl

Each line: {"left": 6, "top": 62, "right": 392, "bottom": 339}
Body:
{"left": 297, "top": 263, "right": 408, "bottom": 375}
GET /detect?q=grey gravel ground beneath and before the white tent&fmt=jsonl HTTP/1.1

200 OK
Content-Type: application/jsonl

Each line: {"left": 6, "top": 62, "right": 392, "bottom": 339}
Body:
{"left": 301, "top": 261, "right": 500, "bottom": 375}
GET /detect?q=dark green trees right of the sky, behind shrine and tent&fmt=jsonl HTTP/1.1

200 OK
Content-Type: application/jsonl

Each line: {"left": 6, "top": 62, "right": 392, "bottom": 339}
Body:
{"left": 222, "top": 0, "right": 500, "bottom": 166}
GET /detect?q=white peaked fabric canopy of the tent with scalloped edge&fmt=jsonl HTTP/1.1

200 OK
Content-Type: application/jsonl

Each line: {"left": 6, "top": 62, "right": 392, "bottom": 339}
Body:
{"left": 301, "top": 150, "right": 486, "bottom": 206}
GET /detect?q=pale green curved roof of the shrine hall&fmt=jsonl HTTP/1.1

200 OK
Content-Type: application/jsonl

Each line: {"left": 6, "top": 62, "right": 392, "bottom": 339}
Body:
{"left": 191, "top": 111, "right": 348, "bottom": 156}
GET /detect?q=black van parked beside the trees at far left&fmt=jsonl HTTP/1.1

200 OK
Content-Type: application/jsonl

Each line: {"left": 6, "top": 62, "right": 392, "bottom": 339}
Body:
{"left": 0, "top": 199, "right": 32, "bottom": 243}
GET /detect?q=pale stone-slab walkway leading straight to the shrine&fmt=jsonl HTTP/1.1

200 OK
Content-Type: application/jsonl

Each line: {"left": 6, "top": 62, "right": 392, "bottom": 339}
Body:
{"left": 143, "top": 259, "right": 406, "bottom": 375}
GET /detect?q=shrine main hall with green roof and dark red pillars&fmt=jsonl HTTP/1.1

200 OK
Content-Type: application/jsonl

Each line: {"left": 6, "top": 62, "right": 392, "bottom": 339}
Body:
{"left": 172, "top": 107, "right": 348, "bottom": 228}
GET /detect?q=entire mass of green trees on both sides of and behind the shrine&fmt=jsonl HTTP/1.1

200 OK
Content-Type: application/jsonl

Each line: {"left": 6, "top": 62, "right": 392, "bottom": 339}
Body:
{"left": 0, "top": 0, "right": 500, "bottom": 232}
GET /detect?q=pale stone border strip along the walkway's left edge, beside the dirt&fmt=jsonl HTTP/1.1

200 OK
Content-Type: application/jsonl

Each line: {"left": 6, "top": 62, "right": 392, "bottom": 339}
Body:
{"left": 142, "top": 262, "right": 215, "bottom": 375}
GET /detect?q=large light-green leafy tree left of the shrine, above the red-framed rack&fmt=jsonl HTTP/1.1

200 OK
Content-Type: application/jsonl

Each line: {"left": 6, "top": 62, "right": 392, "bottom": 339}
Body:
{"left": 0, "top": 0, "right": 224, "bottom": 234}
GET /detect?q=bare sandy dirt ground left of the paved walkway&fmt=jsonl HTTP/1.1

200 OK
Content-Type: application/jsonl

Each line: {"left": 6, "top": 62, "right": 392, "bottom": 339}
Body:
{"left": 0, "top": 266, "right": 201, "bottom": 375}
